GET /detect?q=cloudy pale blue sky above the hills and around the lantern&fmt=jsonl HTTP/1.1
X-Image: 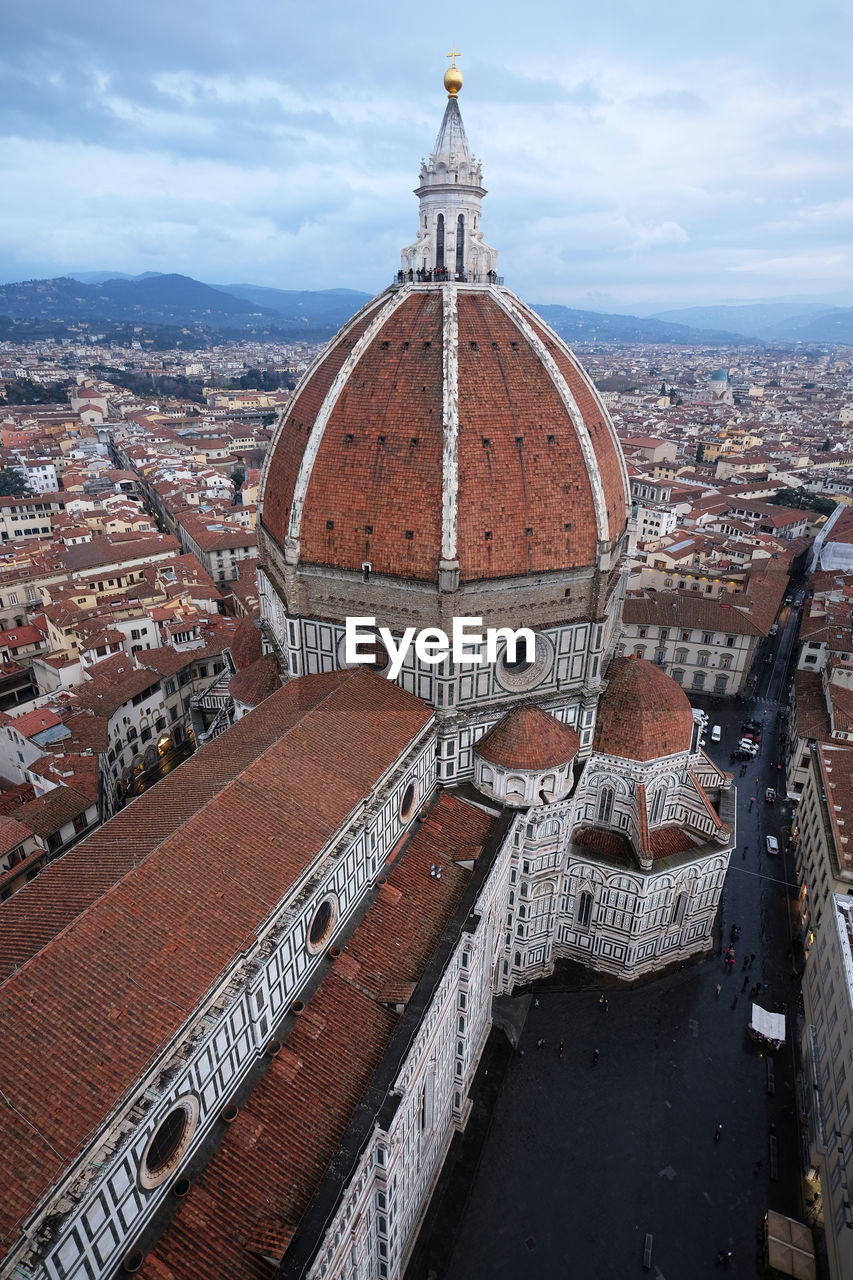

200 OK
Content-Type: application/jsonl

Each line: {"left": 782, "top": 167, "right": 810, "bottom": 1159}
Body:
{"left": 0, "top": 0, "right": 853, "bottom": 312}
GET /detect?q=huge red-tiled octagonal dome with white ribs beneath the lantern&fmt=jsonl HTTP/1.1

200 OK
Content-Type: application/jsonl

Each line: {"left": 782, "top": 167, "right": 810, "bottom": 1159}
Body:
{"left": 261, "top": 284, "right": 628, "bottom": 582}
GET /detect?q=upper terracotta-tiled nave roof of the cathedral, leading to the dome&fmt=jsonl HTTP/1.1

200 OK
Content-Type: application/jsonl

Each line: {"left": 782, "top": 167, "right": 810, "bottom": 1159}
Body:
{"left": 0, "top": 668, "right": 430, "bottom": 1242}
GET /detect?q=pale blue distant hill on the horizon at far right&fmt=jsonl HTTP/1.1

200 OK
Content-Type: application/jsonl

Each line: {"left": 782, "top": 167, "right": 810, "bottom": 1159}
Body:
{"left": 653, "top": 302, "right": 853, "bottom": 342}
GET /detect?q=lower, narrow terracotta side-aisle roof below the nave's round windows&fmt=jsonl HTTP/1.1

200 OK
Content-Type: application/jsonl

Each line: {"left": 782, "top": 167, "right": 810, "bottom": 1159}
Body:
{"left": 140, "top": 794, "right": 493, "bottom": 1280}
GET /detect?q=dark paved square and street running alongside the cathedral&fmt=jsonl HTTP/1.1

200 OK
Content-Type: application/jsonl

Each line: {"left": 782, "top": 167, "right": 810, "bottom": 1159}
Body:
{"left": 407, "top": 611, "right": 802, "bottom": 1280}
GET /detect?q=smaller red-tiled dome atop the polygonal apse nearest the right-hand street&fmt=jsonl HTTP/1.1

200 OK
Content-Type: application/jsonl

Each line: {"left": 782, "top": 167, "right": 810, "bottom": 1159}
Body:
{"left": 593, "top": 658, "right": 693, "bottom": 760}
